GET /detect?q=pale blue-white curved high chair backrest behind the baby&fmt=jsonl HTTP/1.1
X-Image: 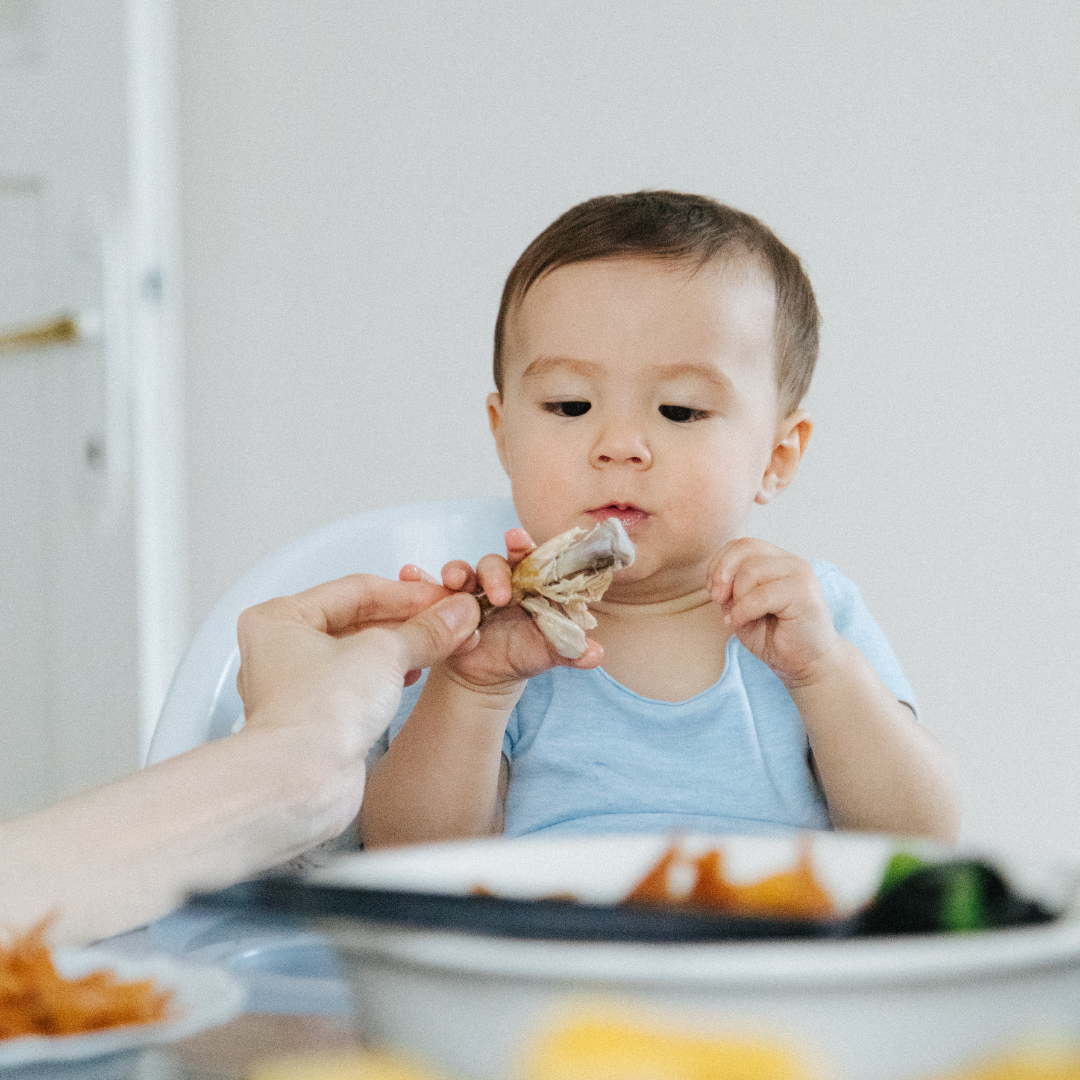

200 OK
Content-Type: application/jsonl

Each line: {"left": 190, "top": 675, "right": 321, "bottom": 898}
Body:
{"left": 147, "top": 498, "right": 517, "bottom": 765}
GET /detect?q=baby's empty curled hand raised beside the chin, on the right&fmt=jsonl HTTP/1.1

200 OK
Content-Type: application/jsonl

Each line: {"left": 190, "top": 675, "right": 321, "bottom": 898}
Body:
{"left": 705, "top": 537, "right": 840, "bottom": 687}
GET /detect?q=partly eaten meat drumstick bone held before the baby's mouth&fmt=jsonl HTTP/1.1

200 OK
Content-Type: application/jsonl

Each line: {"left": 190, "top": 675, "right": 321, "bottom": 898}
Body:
{"left": 494, "top": 517, "right": 634, "bottom": 660}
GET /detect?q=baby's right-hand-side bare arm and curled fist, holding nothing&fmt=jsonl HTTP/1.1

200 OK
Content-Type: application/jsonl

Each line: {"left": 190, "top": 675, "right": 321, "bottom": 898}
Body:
{"left": 707, "top": 539, "right": 960, "bottom": 840}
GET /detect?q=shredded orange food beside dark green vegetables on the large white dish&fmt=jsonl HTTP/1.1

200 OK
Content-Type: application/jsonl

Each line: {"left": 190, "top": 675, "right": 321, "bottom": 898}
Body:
{"left": 624, "top": 839, "right": 834, "bottom": 919}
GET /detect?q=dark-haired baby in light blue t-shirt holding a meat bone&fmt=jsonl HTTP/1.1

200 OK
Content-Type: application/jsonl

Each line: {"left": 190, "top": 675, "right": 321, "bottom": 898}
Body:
{"left": 361, "top": 191, "right": 959, "bottom": 847}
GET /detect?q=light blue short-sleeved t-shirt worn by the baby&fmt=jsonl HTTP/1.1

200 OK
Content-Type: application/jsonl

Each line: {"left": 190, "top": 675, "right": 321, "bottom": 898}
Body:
{"left": 375, "top": 562, "right": 916, "bottom": 836}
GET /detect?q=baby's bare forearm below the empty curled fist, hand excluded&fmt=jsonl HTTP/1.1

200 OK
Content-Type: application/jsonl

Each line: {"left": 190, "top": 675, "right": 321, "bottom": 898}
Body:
{"left": 788, "top": 640, "right": 960, "bottom": 840}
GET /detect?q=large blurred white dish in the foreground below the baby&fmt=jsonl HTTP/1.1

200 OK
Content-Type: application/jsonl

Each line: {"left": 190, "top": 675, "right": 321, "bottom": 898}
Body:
{"left": 298, "top": 834, "right": 1080, "bottom": 1080}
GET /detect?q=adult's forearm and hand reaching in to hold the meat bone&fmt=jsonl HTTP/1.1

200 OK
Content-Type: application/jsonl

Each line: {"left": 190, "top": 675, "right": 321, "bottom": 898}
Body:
{"left": 0, "top": 575, "right": 480, "bottom": 943}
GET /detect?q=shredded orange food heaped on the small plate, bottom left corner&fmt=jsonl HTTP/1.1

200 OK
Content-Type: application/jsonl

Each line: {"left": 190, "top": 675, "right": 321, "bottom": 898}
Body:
{"left": 0, "top": 919, "right": 173, "bottom": 1039}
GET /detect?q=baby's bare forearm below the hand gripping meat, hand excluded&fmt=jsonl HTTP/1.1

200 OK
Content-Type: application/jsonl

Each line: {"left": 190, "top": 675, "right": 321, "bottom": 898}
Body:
{"left": 360, "top": 667, "right": 523, "bottom": 848}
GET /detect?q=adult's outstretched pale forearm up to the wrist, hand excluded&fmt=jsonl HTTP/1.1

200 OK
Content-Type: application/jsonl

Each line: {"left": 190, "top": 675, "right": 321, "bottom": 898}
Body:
{"left": 0, "top": 727, "right": 364, "bottom": 942}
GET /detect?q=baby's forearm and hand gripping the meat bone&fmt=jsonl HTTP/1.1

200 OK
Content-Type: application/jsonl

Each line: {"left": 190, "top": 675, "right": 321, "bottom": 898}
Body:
{"left": 360, "top": 529, "right": 603, "bottom": 848}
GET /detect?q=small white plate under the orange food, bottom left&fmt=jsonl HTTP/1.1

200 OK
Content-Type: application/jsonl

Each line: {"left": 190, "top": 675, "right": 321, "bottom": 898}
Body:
{"left": 0, "top": 949, "right": 244, "bottom": 1069}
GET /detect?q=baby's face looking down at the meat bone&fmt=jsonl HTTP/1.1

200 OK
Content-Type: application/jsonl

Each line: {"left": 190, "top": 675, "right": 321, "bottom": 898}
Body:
{"left": 488, "top": 259, "right": 794, "bottom": 603}
